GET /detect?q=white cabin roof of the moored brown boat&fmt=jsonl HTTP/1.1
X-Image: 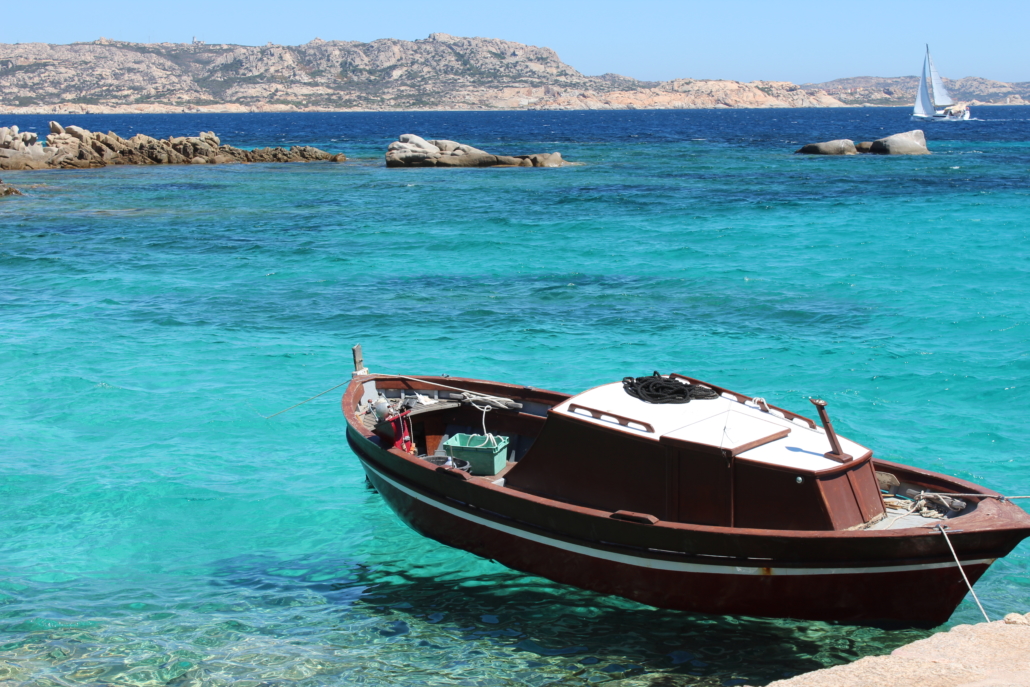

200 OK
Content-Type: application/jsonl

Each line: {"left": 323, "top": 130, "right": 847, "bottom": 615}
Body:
{"left": 552, "top": 382, "right": 869, "bottom": 472}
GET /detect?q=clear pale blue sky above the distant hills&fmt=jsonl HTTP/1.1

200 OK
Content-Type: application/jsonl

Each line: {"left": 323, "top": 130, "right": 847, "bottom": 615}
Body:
{"left": 0, "top": 0, "right": 1030, "bottom": 83}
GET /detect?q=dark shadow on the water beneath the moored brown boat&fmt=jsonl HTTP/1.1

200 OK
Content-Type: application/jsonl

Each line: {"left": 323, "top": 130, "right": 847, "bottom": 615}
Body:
{"left": 355, "top": 566, "right": 928, "bottom": 685}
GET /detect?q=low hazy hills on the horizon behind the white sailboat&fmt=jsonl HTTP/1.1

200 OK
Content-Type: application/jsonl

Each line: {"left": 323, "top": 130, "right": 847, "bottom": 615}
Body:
{"left": 802, "top": 76, "right": 1030, "bottom": 105}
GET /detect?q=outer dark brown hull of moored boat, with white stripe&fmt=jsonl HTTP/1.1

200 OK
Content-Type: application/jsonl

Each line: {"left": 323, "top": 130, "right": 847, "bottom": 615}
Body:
{"left": 344, "top": 376, "right": 1030, "bottom": 626}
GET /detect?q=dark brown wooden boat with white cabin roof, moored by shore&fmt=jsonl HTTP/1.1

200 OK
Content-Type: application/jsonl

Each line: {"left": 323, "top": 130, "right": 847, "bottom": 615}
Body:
{"left": 343, "top": 357, "right": 1030, "bottom": 625}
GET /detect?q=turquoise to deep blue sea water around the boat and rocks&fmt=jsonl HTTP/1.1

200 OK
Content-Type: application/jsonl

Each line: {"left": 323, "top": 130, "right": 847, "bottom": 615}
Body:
{"left": 6, "top": 107, "right": 1030, "bottom": 687}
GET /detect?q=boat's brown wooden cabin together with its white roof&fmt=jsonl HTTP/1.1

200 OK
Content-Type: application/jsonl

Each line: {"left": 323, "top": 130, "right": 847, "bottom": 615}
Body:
{"left": 506, "top": 380, "right": 884, "bottom": 529}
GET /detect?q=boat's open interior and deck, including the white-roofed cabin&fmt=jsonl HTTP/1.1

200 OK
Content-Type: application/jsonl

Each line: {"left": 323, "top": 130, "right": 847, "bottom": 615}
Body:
{"left": 349, "top": 375, "right": 979, "bottom": 531}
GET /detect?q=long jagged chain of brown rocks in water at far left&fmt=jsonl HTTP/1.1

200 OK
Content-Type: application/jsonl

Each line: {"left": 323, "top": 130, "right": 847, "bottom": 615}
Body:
{"left": 0, "top": 122, "right": 346, "bottom": 170}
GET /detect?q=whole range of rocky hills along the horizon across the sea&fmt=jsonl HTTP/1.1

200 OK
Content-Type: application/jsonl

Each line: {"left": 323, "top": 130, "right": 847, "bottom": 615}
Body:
{"left": 0, "top": 33, "right": 1030, "bottom": 114}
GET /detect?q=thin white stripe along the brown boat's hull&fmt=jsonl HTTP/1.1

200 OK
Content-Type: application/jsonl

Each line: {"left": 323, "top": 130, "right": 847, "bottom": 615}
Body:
{"left": 364, "top": 461, "right": 994, "bottom": 577}
